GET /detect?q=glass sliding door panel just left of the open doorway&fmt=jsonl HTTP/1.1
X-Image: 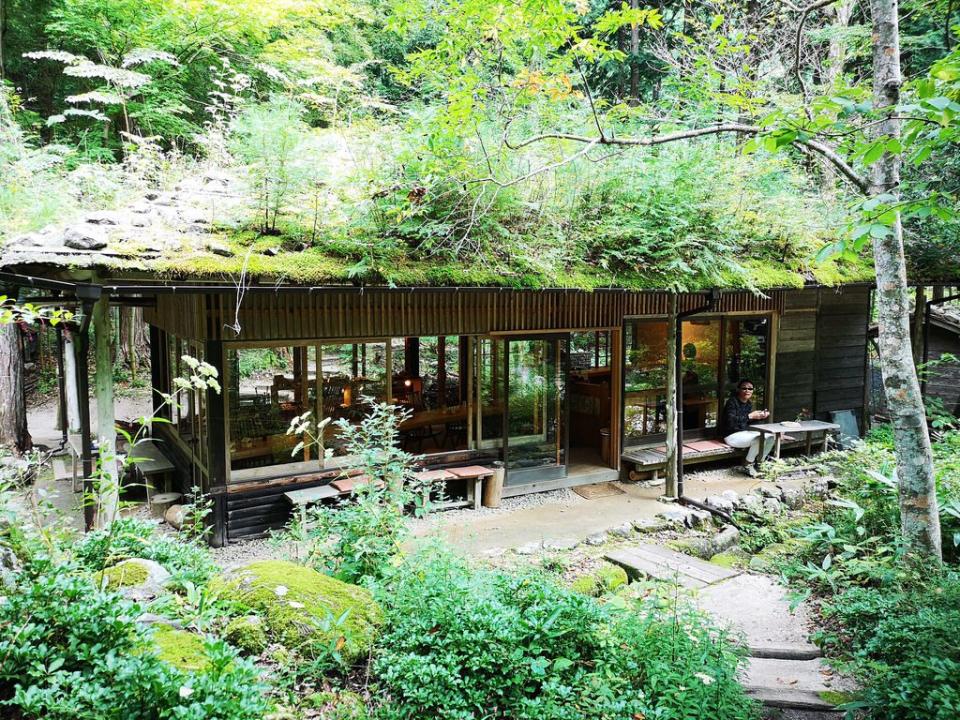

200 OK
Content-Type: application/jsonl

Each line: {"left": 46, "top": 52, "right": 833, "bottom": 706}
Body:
{"left": 506, "top": 340, "right": 566, "bottom": 481}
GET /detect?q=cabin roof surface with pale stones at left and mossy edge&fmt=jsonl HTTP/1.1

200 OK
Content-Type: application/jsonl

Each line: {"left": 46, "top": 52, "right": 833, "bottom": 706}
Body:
{"left": 0, "top": 167, "right": 873, "bottom": 290}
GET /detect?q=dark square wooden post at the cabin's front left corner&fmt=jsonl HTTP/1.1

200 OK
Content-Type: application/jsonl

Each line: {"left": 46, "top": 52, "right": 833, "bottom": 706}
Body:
{"left": 203, "top": 340, "right": 230, "bottom": 547}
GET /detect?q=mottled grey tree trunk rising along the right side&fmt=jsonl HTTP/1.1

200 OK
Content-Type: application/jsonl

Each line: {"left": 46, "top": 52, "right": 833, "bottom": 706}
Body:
{"left": 870, "top": 0, "right": 941, "bottom": 562}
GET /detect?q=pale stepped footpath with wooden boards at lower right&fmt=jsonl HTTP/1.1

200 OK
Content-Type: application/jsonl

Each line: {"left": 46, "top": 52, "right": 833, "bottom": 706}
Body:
{"left": 606, "top": 543, "right": 853, "bottom": 718}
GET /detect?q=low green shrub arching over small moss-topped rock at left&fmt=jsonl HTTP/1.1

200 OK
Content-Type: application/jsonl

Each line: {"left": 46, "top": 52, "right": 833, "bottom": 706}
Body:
{"left": 74, "top": 518, "right": 217, "bottom": 587}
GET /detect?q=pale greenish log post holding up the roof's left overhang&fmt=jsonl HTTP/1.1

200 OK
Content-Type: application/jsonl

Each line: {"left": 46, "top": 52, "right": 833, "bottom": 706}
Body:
{"left": 93, "top": 293, "right": 120, "bottom": 528}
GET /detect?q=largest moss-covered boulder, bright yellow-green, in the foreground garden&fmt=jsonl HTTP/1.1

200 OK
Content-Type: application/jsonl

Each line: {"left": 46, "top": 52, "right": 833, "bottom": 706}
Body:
{"left": 210, "top": 560, "right": 383, "bottom": 663}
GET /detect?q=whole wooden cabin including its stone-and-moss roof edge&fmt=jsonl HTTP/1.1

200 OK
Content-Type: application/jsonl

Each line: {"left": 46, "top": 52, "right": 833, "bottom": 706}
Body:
{"left": 0, "top": 173, "right": 884, "bottom": 544}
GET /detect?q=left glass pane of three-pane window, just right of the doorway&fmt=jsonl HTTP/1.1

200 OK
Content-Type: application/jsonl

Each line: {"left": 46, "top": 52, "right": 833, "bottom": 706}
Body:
{"left": 623, "top": 320, "right": 667, "bottom": 446}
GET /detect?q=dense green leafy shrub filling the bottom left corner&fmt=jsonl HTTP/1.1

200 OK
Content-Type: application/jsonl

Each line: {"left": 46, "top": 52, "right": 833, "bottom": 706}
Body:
{"left": 0, "top": 564, "right": 269, "bottom": 720}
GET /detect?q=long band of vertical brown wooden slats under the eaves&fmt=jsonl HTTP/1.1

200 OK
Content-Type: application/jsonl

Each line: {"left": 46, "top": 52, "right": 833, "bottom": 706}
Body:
{"left": 145, "top": 289, "right": 784, "bottom": 342}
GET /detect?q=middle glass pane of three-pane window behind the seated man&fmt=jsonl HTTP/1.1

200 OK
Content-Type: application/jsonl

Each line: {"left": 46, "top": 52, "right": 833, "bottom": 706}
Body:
{"left": 680, "top": 318, "right": 720, "bottom": 430}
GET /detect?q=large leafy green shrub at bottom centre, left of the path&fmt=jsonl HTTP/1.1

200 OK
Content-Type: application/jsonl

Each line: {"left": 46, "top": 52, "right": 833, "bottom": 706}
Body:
{"left": 373, "top": 550, "right": 755, "bottom": 720}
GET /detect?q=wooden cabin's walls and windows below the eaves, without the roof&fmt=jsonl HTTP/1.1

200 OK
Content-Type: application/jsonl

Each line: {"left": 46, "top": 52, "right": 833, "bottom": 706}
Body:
{"left": 0, "top": 276, "right": 870, "bottom": 544}
